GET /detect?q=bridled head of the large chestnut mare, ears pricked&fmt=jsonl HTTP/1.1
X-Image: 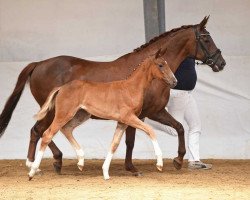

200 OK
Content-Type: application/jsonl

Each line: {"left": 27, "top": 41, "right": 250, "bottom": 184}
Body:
{"left": 193, "top": 16, "right": 226, "bottom": 72}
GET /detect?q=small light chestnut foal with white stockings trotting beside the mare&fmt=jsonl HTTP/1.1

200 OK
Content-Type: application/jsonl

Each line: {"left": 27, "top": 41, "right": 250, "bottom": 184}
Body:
{"left": 29, "top": 50, "right": 177, "bottom": 180}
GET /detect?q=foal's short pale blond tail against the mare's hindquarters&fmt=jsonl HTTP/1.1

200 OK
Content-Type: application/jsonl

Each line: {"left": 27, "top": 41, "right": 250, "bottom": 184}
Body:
{"left": 34, "top": 87, "right": 61, "bottom": 121}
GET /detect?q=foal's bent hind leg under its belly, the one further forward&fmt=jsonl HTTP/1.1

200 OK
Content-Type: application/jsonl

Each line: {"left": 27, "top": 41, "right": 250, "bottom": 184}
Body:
{"left": 61, "top": 109, "right": 91, "bottom": 171}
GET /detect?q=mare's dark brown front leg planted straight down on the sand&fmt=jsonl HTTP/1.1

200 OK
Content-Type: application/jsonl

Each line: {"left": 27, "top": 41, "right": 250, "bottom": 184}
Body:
{"left": 125, "top": 126, "right": 142, "bottom": 176}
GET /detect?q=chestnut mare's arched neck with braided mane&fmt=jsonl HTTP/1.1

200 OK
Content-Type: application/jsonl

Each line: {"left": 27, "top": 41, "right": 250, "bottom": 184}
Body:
{"left": 114, "top": 27, "right": 196, "bottom": 75}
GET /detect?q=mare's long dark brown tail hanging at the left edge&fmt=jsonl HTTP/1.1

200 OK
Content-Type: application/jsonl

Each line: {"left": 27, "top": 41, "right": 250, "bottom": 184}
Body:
{"left": 0, "top": 63, "right": 37, "bottom": 137}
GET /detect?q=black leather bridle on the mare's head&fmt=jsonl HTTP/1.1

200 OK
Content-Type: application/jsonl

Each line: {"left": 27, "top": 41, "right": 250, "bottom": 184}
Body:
{"left": 194, "top": 27, "right": 221, "bottom": 68}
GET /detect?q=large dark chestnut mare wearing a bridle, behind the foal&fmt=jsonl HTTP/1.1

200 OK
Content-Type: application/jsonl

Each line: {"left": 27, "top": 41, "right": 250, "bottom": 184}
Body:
{"left": 0, "top": 17, "right": 226, "bottom": 175}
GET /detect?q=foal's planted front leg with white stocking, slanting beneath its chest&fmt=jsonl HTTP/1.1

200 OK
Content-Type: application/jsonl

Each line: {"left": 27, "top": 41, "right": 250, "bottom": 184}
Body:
{"left": 102, "top": 122, "right": 127, "bottom": 180}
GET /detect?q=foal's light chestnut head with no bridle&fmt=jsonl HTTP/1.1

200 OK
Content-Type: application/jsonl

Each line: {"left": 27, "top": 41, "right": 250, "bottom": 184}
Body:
{"left": 152, "top": 49, "right": 177, "bottom": 88}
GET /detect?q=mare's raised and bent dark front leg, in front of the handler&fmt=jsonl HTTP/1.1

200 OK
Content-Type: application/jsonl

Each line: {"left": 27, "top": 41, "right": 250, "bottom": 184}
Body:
{"left": 149, "top": 109, "right": 186, "bottom": 170}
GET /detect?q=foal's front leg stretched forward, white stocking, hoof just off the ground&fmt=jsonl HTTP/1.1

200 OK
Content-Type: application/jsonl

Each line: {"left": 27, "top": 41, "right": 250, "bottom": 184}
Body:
{"left": 126, "top": 115, "right": 163, "bottom": 171}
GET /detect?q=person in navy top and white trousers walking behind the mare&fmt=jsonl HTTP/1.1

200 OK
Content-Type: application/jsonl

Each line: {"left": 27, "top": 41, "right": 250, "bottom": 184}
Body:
{"left": 145, "top": 58, "right": 212, "bottom": 169}
